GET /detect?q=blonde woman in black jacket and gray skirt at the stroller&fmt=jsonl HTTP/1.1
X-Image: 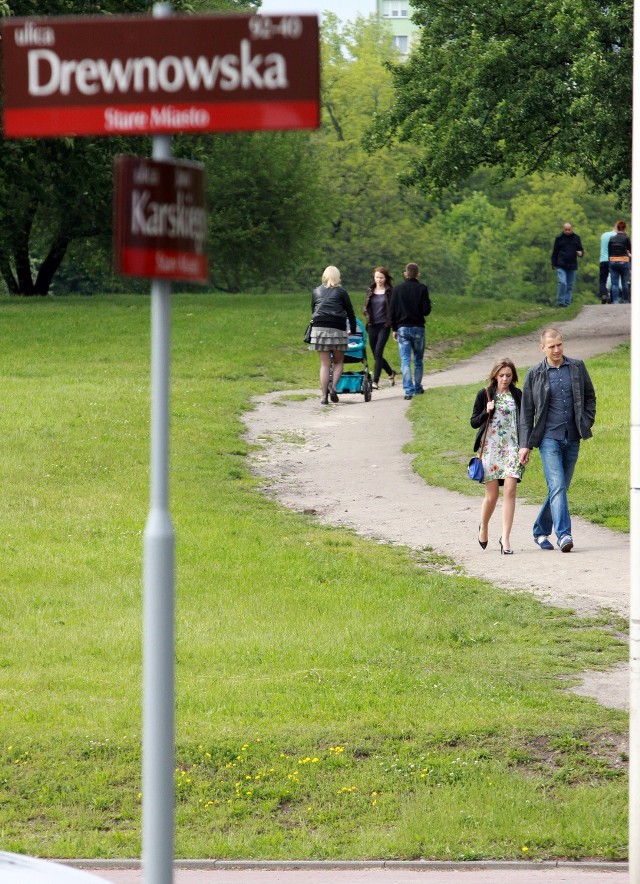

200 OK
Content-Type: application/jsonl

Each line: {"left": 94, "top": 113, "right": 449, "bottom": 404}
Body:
{"left": 309, "top": 266, "right": 358, "bottom": 405}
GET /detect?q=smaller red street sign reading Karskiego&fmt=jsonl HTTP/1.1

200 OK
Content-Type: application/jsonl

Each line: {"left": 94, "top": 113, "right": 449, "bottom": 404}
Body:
{"left": 114, "top": 157, "right": 209, "bottom": 282}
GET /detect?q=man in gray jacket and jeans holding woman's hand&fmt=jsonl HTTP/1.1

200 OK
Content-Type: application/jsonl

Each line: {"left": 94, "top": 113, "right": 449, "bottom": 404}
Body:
{"left": 518, "top": 328, "right": 596, "bottom": 552}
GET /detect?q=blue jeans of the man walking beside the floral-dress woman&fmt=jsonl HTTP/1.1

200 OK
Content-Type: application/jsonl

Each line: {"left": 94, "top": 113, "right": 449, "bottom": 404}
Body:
{"left": 533, "top": 436, "right": 580, "bottom": 541}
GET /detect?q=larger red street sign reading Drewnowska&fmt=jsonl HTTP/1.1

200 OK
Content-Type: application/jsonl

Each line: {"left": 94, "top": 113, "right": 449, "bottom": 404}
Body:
{"left": 1, "top": 15, "right": 320, "bottom": 138}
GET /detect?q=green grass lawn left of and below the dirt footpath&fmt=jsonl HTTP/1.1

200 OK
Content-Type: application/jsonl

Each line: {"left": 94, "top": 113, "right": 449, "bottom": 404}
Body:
{"left": 0, "top": 293, "right": 627, "bottom": 859}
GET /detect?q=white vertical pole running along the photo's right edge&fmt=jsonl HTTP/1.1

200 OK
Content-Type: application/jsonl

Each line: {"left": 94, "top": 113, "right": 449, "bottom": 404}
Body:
{"left": 629, "top": 2, "right": 640, "bottom": 884}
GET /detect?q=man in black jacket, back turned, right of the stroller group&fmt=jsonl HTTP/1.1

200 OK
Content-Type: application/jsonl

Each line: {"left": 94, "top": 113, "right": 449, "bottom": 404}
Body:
{"left": 391, "top": 264, "right": 431, "bottom": 399}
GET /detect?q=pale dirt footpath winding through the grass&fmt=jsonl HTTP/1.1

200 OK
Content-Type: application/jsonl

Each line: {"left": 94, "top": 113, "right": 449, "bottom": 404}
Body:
{"left": 245, "top": 304, "right": 631, "bottom": 708}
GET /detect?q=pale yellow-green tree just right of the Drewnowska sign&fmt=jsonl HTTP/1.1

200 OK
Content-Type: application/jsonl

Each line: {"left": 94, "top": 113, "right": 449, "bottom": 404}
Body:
{"left": 304, "top": 15, "right": 440, "bottom": 291}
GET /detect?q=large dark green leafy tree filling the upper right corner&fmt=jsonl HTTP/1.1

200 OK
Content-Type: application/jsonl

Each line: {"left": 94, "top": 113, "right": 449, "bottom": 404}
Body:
{"left": 366, "top": 0, "right": 633, "bottom": 197}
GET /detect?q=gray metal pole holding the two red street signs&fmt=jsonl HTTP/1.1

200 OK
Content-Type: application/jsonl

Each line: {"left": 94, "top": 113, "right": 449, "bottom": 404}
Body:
{"left": 142, "top": 3, "right": 175, "bottom": 884}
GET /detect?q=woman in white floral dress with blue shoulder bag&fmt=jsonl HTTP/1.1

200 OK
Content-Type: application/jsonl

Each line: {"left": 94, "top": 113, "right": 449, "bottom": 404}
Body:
{"left": 471, "top": 359, "right": 524, "bottom": 555}
